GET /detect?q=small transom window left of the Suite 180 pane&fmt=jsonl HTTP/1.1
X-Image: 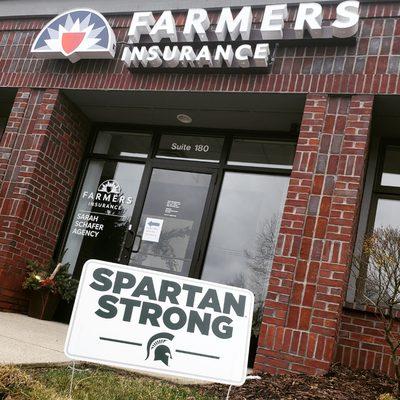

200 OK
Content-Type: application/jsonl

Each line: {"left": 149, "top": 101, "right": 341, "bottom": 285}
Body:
{"left": 93, "top": 131, "right": 151, "bottom": 158}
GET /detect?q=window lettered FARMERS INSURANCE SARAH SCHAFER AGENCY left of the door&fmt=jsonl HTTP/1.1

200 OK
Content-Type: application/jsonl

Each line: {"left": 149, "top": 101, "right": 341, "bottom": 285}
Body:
{"left": 63, "top": 160, "right": 144, "bottom": 276}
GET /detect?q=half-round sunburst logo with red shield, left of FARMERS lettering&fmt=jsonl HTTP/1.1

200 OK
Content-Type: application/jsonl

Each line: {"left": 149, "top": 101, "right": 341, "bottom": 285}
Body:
{"left": 31, "top": 8, "right": 116, "bottom": 63}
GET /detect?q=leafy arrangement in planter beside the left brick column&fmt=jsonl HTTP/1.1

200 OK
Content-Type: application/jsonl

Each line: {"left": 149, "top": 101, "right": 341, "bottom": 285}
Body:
{"left": 22, "top": 261, "right": 79, "bottom": 302}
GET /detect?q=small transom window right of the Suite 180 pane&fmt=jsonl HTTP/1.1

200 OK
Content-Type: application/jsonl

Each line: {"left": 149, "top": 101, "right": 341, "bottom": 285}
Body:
{"left": 228, "top": 139, "right": 296, "bottom": 169}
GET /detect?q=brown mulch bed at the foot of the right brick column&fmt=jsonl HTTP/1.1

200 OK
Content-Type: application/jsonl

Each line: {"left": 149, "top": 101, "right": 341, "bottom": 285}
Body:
{"left": 205, "top": 365, "right": 394, "bottom": 400}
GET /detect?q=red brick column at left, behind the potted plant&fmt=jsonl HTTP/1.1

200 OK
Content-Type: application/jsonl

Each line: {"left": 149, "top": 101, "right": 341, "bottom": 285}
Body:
{"left": 0, "top": 89, "right": 89, "bottom": 311}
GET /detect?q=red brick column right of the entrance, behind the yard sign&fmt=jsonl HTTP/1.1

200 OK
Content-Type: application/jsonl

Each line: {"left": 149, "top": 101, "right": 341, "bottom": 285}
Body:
{"left": 255, "top": 94, "right": 373, "bottom": 375}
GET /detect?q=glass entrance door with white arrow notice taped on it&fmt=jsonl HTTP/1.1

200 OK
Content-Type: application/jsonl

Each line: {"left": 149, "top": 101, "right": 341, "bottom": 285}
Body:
{"left": 128, "top": 168, "right": 212, "bottom": 276}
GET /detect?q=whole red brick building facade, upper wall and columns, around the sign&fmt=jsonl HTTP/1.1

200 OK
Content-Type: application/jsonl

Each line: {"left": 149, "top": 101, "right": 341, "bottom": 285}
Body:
{"left": 0, "top": 1, "right": 400, "bottom": 374}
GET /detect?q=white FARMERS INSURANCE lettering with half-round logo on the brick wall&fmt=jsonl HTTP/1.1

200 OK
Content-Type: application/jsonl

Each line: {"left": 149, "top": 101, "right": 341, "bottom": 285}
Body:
{"left": 31, "top": 1, "right": 360, "bottom": 68}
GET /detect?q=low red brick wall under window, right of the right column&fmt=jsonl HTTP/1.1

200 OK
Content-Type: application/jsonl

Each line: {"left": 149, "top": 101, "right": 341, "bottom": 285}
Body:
{"left": 335, "top": 308, "right": 400, "bottom": 376}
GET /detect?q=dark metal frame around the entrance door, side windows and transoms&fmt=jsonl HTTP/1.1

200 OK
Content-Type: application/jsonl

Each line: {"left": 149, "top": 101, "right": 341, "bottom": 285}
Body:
{"left": 55, "top": 124, "right": 298, "bottom": 279}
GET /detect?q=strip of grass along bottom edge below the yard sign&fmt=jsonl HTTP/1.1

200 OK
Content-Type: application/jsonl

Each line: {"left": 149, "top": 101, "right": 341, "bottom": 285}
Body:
{"left": 0, "top": 366, "right": 217, "bottom": 400}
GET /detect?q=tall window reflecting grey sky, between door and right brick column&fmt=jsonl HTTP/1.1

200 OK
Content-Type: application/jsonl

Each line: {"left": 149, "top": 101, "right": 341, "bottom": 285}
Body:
{"left": 202, "top": 172, "right": 289, "bottom": 335}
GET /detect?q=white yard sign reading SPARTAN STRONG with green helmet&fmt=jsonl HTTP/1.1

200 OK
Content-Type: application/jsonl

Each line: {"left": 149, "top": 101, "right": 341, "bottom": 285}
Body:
{"left": 65, "top": 260, "right": 254, "bottom": 385}
